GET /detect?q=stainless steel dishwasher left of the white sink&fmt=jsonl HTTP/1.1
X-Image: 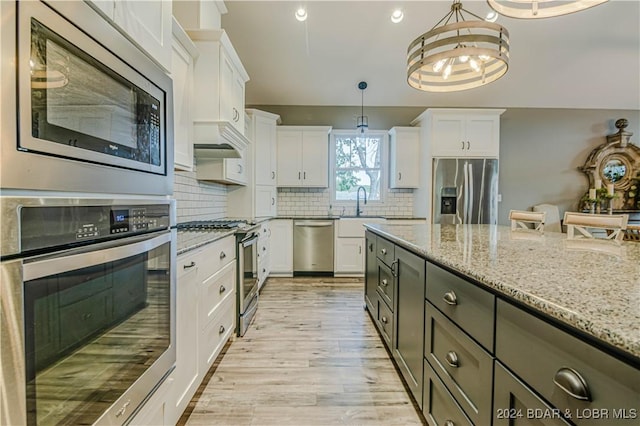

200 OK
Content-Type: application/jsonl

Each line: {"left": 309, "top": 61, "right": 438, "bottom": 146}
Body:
{"left": 293, "top": 219, "right": 334, "bottom": 276}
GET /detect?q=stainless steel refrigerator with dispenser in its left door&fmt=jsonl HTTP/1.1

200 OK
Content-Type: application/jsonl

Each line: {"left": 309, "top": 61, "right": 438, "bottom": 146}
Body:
{"left": 432, "top": 158, "right": 498, "bottom": 224}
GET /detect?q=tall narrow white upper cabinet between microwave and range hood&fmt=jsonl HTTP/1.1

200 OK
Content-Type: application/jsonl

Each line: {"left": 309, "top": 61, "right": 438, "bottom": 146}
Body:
{"left": 171, "top": 19, "right": 198, "bottom": 171}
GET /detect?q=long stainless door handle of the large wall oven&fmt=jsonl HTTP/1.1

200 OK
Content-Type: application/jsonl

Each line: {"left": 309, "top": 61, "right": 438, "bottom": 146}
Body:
{"left": 23, "top": 231, "right": 173, "bottom": 282}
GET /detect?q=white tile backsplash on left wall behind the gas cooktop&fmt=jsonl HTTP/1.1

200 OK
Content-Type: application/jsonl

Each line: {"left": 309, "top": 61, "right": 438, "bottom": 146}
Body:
{"left": 173, "top": 171, "right": 227, "bottom": 223}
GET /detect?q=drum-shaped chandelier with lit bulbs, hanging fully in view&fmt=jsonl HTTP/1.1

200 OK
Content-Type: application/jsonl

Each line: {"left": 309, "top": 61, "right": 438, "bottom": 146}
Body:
{"left": 407, "top": 0, "right": 509, "bottom": 92}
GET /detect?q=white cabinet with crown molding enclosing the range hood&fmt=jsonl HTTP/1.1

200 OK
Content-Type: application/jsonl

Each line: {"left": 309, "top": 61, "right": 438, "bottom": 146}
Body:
{"left": 187, "top": 30, "right": 249, "bottom": 135}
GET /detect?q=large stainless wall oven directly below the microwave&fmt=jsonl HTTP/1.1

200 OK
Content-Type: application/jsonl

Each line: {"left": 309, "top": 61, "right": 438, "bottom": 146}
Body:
{"left": 0, "top": 197, "right": 176, "bottom": 425}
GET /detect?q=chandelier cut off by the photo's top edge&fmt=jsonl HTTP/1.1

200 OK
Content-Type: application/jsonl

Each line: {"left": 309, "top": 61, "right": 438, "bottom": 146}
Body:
{"left": 487, "top": 0, "right": 608, "bottom": 19}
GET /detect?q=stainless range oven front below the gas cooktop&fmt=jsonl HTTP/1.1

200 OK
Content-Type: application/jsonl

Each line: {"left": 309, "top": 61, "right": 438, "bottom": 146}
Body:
{"left": 236, "top": 231, "right": 258, "bottom": 336}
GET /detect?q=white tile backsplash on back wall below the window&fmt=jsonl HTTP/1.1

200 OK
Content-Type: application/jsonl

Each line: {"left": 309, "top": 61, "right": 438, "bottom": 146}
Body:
{"left": 278, "top": 188, "right": 413, "bottom": 217}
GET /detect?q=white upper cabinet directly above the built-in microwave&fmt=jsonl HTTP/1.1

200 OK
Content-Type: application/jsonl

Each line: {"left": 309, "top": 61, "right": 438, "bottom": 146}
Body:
{"left": 113, "top": 0, "right": 173, "bottom": 71}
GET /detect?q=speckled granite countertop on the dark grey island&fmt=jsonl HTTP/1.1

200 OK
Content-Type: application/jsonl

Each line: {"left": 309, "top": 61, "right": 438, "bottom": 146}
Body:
{"left": 365, "top": 224, "right": 640, "bottom": 362}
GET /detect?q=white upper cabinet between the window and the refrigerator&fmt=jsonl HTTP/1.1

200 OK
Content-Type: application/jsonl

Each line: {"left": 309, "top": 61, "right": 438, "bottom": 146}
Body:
{"left": 389, "top": 127, "right": 420, "bottom": 188}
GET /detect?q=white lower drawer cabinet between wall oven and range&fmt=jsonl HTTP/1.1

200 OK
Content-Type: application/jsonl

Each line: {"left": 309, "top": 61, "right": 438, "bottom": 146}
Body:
{"left": 164, "top": 235, "right": 236, "bottom": 425}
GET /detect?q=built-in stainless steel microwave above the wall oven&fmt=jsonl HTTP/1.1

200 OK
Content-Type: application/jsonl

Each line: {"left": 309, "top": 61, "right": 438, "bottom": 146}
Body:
{"left": 0, "top": 1, "right": 173, "bottom": 195}
